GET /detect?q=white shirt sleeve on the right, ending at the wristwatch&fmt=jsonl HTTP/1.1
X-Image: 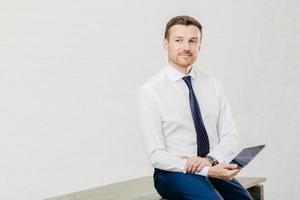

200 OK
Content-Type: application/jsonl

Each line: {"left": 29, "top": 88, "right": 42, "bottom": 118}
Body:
{"left": 209, "top": 81, "right": 238, "bottom": 163}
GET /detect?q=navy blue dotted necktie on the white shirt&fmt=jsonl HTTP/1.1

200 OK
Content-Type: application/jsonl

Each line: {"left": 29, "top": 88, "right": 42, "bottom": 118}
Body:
{"left": 182, "top": 76, "right": 209, "bottom": 157}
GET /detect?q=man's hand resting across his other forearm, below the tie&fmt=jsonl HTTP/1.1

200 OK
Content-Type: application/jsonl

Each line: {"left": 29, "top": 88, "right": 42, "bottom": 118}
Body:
{"left": 181, "top": 156, "right": 211, "bottom": 173}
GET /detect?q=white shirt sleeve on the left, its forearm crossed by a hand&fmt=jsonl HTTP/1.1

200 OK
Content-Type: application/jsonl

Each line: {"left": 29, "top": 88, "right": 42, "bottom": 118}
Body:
{"left": 138, "top": 87, "right": 208, "bottom": 176}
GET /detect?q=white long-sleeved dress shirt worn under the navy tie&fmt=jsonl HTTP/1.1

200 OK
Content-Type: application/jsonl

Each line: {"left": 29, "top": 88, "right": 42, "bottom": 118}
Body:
{"left": 138, "top": 64, "right": 237, "bottom": 176}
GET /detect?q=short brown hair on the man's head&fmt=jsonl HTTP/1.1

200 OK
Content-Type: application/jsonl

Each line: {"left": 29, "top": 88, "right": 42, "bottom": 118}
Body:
{"left": 165, "top": 15, "right": 202, "bottom": 39}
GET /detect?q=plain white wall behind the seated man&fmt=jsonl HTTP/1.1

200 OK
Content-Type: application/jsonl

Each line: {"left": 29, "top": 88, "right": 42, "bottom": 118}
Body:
{"left": 0, "top": 0, "right": 300, "bottom": 200}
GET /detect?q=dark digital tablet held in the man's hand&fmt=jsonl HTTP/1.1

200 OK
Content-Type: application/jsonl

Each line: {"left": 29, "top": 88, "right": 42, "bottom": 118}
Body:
{"left": 230, "top": 145, "right": 266, "bottom": 168}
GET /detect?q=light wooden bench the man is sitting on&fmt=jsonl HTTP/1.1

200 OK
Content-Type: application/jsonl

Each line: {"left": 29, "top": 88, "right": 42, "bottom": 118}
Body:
{"left": 48, "top": 177, "right": 266, "bottom": 200}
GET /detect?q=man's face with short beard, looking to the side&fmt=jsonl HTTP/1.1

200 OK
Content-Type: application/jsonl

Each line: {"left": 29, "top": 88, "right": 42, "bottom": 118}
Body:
{"left": 163, "top": 25, "right": 201, "bottom": 68}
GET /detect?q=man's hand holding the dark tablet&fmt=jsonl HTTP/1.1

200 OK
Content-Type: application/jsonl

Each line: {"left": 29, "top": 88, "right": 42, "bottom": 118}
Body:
{"left": 208, "top": 163, "right": 240, "bottom": 180}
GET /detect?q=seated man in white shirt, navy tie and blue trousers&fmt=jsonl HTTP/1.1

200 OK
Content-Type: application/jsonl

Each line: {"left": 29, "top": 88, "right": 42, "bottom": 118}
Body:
{"left": 139, "top": 16, "right": 252, "bottom": 200}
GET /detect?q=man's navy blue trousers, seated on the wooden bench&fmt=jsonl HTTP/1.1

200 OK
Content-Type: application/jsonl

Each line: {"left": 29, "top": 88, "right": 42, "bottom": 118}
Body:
{"left": 153, "top": 169, "right": 253, "bottom": 200}
